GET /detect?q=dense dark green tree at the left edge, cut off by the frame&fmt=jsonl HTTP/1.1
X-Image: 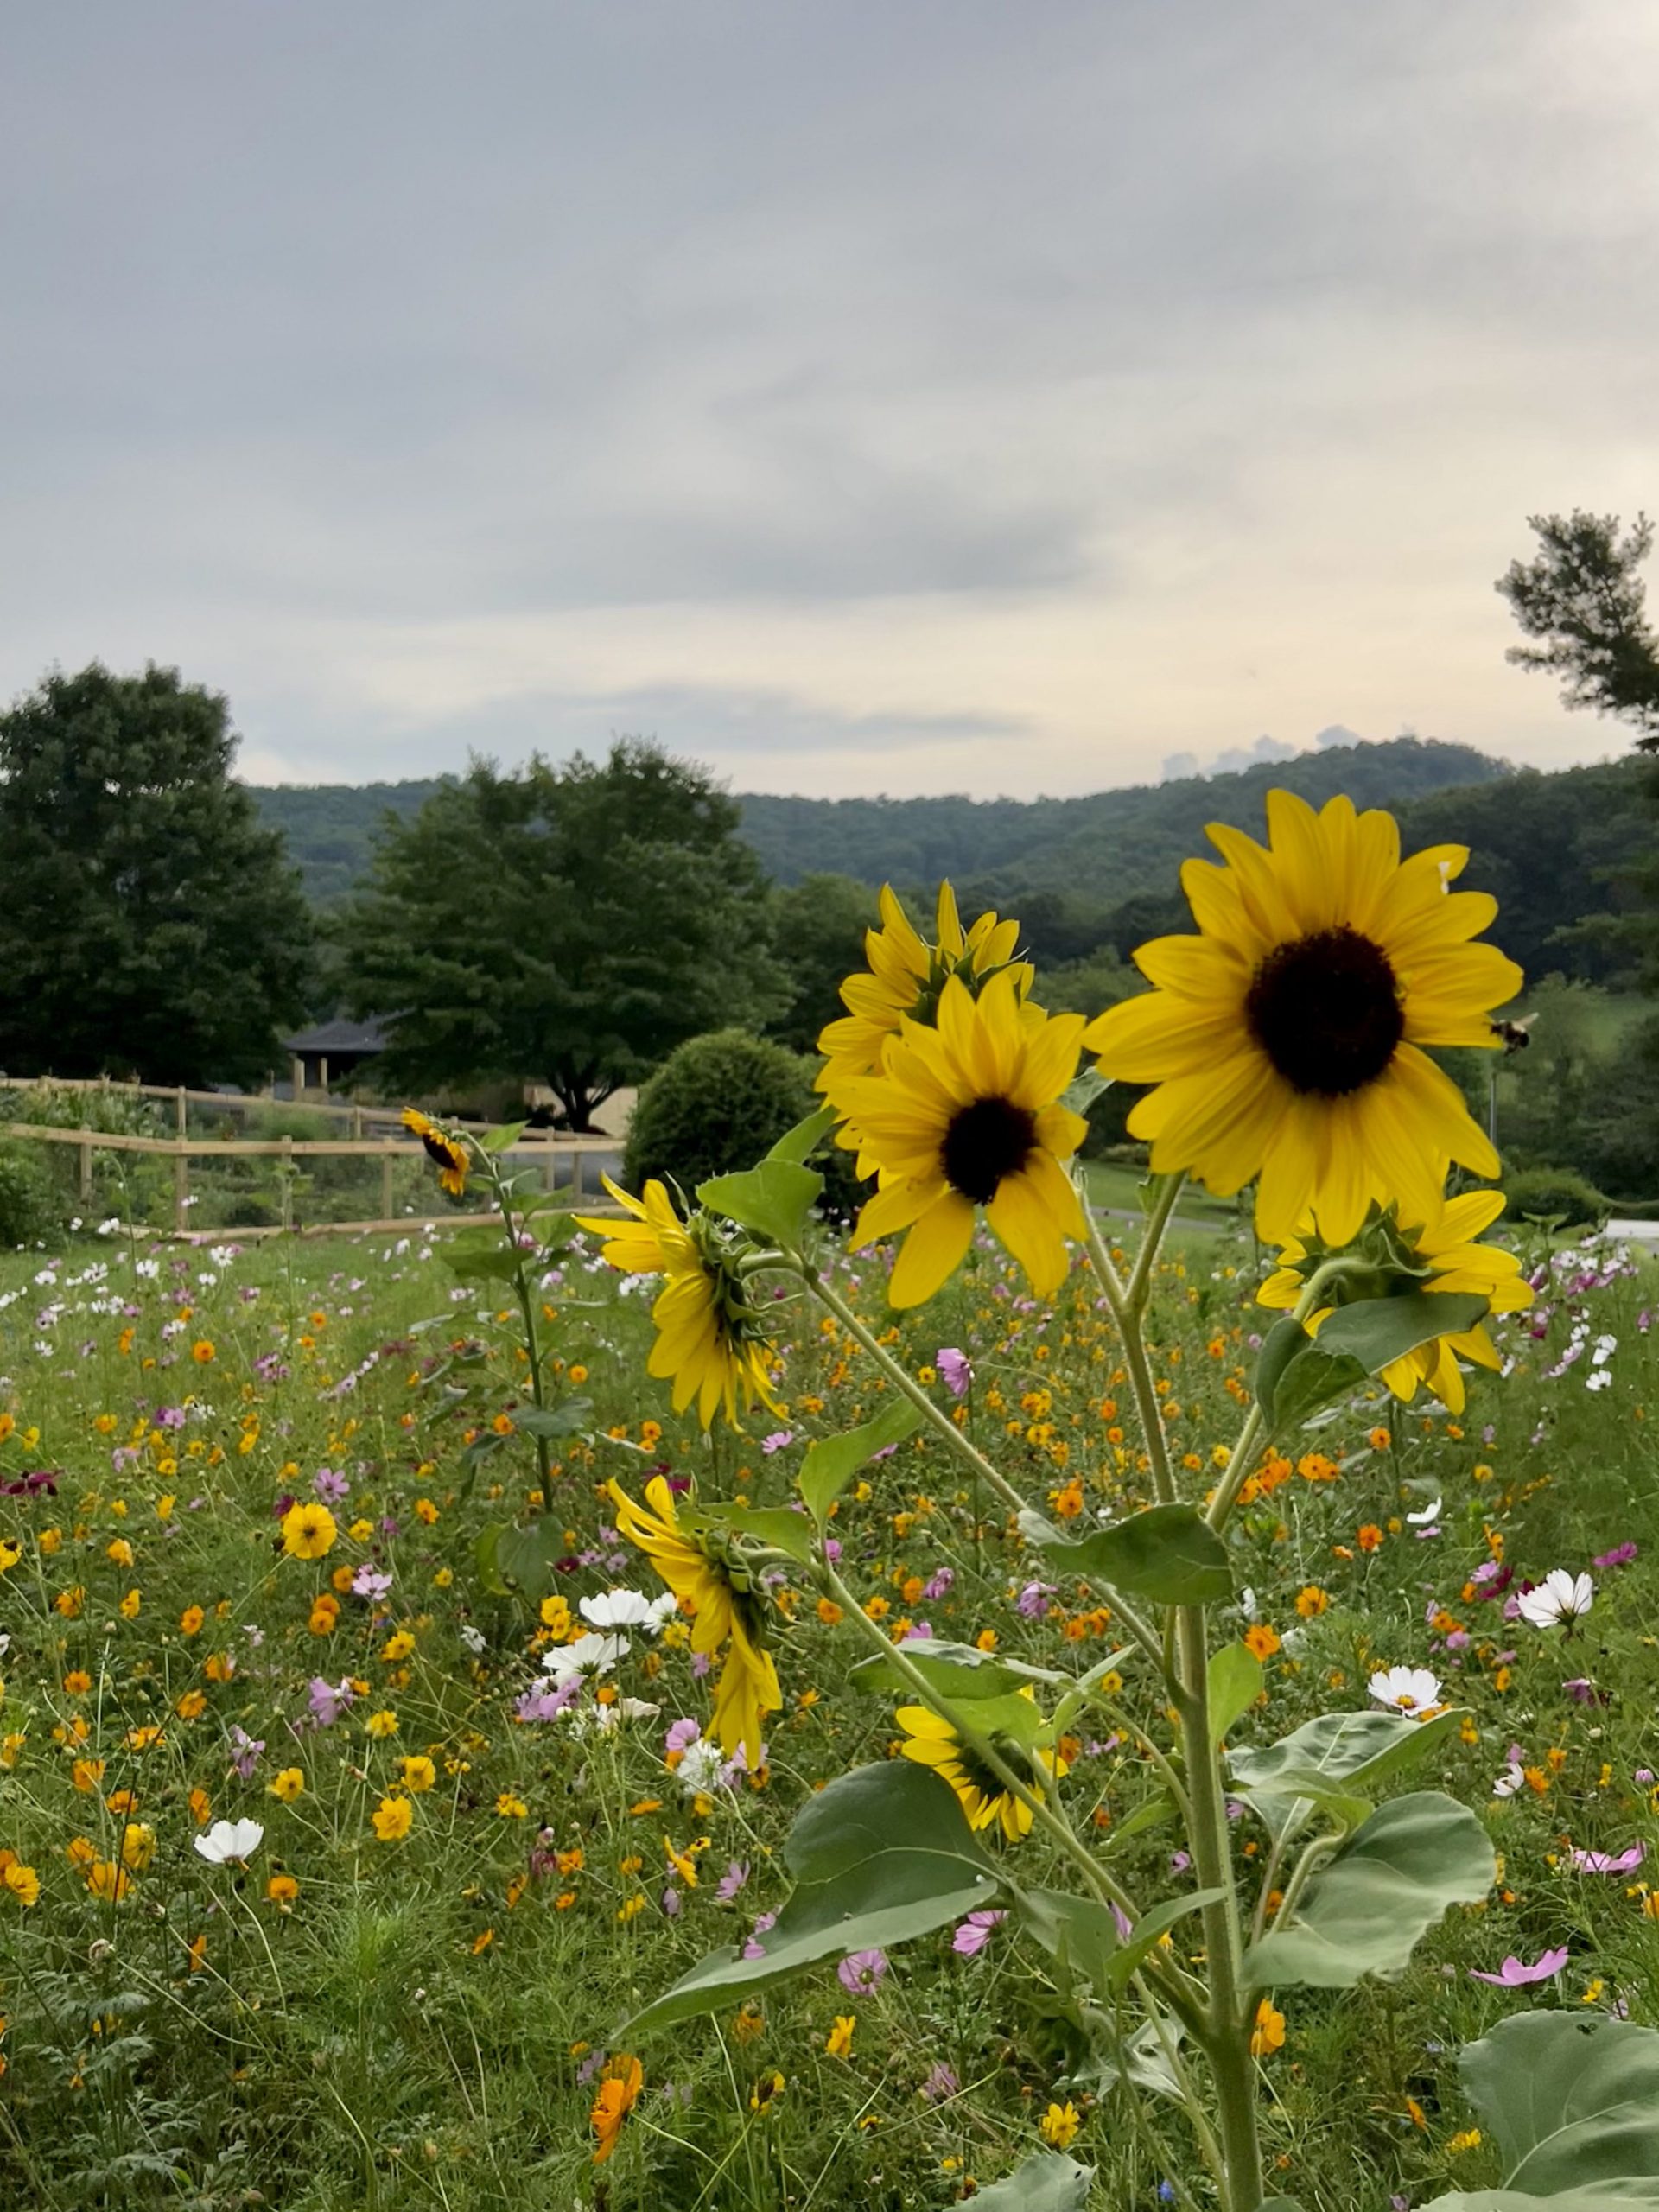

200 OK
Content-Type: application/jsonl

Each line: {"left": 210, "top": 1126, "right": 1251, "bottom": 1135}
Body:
{"left": 0, "top": 661, "right": 312, "bottom": 1086}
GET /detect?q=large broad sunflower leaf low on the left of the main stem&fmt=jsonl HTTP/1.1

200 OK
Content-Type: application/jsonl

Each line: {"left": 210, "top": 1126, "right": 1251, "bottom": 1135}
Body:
{"left": 615, "top": 1758, "right": 1002, "bottom": 2042}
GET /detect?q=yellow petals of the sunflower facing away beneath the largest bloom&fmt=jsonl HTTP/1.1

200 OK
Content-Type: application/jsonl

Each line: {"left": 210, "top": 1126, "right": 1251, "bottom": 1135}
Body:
{"left": 1256, "top": 1190, "right": 1533, "bottom": 1414}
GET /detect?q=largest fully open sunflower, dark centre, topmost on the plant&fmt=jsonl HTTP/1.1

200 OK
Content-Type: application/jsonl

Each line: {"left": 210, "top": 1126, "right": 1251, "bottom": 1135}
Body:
{"left": 1084, "top": 791, "right": 1522, "bottom": 1243}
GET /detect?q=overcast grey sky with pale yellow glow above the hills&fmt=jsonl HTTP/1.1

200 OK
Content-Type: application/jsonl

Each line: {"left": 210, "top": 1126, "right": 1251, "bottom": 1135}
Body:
{"left": 0, "top": 0, "right": 1659, "bottom": 794}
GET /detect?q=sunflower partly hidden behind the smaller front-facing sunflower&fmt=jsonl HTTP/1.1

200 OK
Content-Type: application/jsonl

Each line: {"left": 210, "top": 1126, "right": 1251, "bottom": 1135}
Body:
{"left": 817, "top": 882, "right": 1031, "bottom": 1123}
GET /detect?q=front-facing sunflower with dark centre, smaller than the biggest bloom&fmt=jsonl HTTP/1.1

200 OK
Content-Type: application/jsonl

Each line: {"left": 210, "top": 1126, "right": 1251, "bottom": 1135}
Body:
{"left": 836, "top": 969, "right": 1086, "bottom": 1305}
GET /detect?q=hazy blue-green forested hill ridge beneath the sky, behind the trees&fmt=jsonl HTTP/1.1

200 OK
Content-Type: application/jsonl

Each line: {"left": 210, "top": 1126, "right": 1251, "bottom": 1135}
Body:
{"left": 252, "top": 736, "right": 1516, "bottom": 902}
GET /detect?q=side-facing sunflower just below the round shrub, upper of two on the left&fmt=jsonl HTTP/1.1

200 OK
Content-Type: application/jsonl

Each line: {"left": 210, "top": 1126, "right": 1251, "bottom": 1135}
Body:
{"left": 577, "top": 1174, "right": 777, "bottom": 1427}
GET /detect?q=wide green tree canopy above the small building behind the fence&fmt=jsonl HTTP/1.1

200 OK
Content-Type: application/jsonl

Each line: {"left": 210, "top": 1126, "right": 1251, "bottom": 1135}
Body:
{"left": 336, "top": 739, "right": 785, "bottom": 1130}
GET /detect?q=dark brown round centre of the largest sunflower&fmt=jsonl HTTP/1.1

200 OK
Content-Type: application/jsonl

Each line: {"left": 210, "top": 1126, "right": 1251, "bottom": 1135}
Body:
{"left": 1245, "top": 929, "right": 1405, "bottom": 1099}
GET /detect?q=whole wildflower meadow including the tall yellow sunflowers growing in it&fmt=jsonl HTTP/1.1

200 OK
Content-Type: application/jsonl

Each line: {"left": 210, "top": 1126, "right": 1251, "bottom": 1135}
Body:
{"left": 0, "top": 794, "right": 1659, "bottom": 2212}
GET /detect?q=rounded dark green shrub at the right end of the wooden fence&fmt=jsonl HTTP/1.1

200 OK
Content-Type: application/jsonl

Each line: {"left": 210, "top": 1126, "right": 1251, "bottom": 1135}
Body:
{"left": 621, "top": 1028, "right": 858, "bottom": 1214}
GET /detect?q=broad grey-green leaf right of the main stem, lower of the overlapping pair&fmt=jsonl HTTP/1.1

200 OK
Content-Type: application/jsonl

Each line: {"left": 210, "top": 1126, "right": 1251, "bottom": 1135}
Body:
{"left": 1243, "top": 1789, "right": 1497, "bottom": 1988}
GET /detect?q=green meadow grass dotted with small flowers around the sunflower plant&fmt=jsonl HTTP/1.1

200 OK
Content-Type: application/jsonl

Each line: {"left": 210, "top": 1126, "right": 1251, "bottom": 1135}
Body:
{"left": 0, "top": 1221, "right": 1659, "bottom": 2212}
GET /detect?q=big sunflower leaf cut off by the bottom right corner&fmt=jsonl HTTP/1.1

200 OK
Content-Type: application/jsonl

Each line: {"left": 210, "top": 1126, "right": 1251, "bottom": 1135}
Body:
{"left": 1429, "top": 2011, "right": 1659, "bottom": 2212}
